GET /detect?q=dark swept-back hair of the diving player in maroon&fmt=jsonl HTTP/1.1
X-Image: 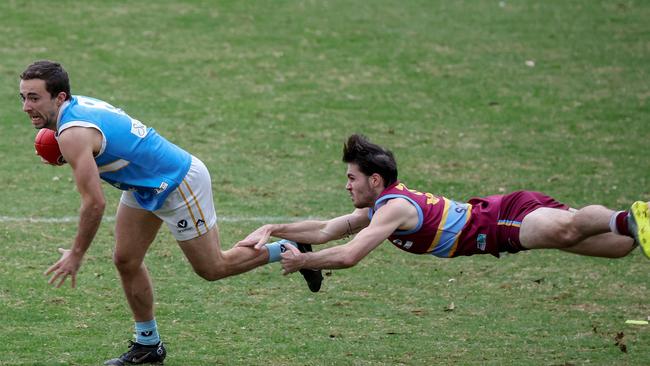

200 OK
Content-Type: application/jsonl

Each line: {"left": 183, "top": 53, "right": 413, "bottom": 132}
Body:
{"left": 343, "top": 134, "right": 397, "bottom": 187}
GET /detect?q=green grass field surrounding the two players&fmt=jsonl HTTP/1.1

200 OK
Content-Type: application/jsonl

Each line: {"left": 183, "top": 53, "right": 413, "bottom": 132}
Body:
{"left": 0, "top": 0, "right": 650, "bottom": 366}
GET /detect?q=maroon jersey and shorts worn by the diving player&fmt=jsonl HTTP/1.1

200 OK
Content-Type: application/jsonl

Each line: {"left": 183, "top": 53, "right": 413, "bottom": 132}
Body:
{"left": 368, "top": 182, "right": 569, "bottom": 258}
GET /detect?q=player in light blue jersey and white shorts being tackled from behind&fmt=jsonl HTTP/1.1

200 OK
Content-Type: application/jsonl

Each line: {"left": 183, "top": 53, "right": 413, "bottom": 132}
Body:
{"left": 20, "top": 61, "right": 322, "bottom": 365}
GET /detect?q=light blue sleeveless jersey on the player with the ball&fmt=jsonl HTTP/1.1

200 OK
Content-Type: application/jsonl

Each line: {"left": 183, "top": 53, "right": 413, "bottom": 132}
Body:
{"left": 57, "top": 95, "right": 192, "bottom": 211}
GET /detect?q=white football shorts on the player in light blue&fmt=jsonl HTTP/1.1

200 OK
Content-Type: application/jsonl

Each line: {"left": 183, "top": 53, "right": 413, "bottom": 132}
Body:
{"left": 120, "top": 156, "right": 217, "bottom": 241}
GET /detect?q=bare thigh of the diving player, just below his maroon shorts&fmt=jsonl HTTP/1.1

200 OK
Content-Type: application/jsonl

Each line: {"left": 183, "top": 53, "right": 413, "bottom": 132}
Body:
{"left": 519, "top": 207, "right": 574, "bottom": 249}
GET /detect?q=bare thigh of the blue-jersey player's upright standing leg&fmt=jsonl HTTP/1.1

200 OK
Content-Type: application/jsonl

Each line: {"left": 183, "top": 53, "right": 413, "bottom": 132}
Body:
{"left": 114, "top": 202, "right": 162, "bottom": 262}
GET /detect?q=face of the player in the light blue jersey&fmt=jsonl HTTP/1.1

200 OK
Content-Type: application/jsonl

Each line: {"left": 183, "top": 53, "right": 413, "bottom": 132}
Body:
{"left": 20, "top": 79, "right": 60, "bottom": 129}
